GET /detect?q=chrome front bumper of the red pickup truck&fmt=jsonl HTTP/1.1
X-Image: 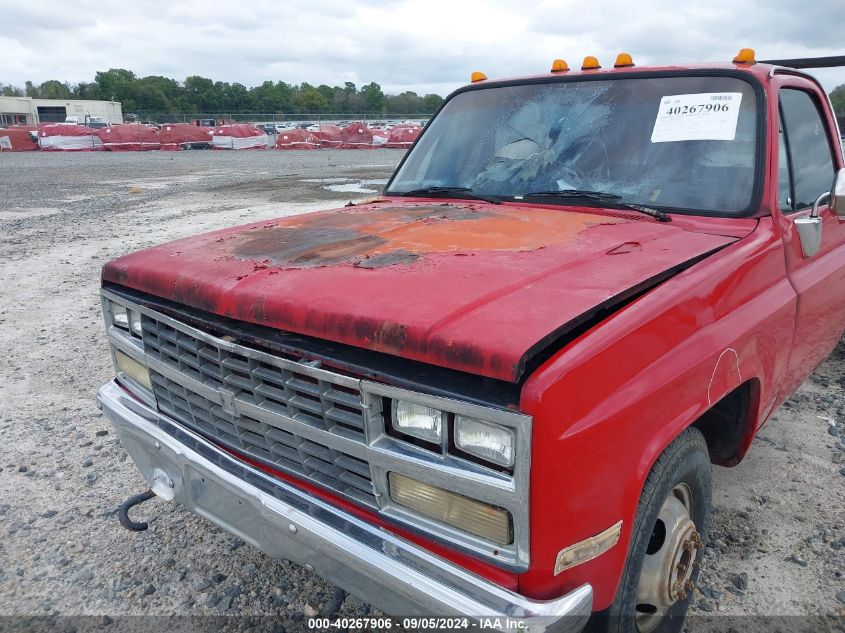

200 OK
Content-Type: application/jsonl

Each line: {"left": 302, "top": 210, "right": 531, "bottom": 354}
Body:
{"left": 97, "top": 381, "right": 593, "bottom": 631}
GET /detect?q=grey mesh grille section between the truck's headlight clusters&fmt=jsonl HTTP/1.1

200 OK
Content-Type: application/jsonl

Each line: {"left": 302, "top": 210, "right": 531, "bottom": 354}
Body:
{"left": 142, "top": 315, "right": 377, "bottom": 507}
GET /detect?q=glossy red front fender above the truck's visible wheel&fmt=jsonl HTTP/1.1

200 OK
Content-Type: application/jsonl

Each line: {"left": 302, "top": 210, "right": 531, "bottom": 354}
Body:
{"left": 519, "top": 218, "right": 796, "bottom": 610}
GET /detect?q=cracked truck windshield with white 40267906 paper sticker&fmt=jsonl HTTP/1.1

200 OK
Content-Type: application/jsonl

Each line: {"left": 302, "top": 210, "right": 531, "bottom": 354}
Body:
{"left": 388, "top": 75, "right": 757, "bottom": 213}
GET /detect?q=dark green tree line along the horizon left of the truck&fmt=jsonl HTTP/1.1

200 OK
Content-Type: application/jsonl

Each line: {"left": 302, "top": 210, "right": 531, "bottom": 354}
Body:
{"left": 0, "top": 68, "right": 443, "bottom": 116}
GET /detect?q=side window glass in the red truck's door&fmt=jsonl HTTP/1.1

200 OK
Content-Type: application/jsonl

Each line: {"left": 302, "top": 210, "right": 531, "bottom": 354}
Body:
{"left": 780, "top": 90, "right": 833, "bottom": 209}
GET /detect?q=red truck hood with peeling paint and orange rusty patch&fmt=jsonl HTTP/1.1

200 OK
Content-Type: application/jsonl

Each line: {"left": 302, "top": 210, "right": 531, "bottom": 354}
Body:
{"left": 103, "top": 200, "right": 737, "bottom": 382}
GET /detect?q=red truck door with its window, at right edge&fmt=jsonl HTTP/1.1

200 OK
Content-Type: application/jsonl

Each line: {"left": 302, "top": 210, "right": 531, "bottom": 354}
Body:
{"left": 774, "top": 75, "right": 845, "bottom": 397}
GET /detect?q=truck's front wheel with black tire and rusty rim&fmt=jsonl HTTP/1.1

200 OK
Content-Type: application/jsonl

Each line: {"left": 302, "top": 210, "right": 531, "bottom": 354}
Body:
{"left": 589, "top": 428, "right": 712, "bottom": 633}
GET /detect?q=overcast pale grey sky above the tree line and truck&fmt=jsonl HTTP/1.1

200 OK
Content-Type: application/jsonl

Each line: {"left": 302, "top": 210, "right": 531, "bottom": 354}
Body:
{"left": 0, "top": 0, "right": 845, "bottom": 95}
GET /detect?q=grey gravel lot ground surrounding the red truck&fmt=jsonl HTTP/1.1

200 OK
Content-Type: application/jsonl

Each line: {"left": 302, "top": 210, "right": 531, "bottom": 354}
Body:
{"left": 0, "top": 150, "right": 845, "bottom": 630}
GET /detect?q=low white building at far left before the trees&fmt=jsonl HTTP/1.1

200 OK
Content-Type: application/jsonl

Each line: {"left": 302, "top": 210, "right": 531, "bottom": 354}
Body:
{"left": 0, "top": 97, "right": 123, "bottom": 127}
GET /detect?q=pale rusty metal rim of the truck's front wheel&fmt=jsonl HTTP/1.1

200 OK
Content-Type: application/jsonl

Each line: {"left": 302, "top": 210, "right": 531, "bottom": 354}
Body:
{"left": 636, "top": 483, "right": 703, "bottom": 633}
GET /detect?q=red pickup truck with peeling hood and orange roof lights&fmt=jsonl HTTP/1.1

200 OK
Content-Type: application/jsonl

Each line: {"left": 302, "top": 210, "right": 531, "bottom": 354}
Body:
{"left": 98, "top": 51, "right": 845, "bottom": 633}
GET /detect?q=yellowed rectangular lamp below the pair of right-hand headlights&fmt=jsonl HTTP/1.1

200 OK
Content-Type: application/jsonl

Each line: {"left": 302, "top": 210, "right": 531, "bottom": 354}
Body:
{"left": 388, "top": 473, "right": 513, "bottom": 545}
